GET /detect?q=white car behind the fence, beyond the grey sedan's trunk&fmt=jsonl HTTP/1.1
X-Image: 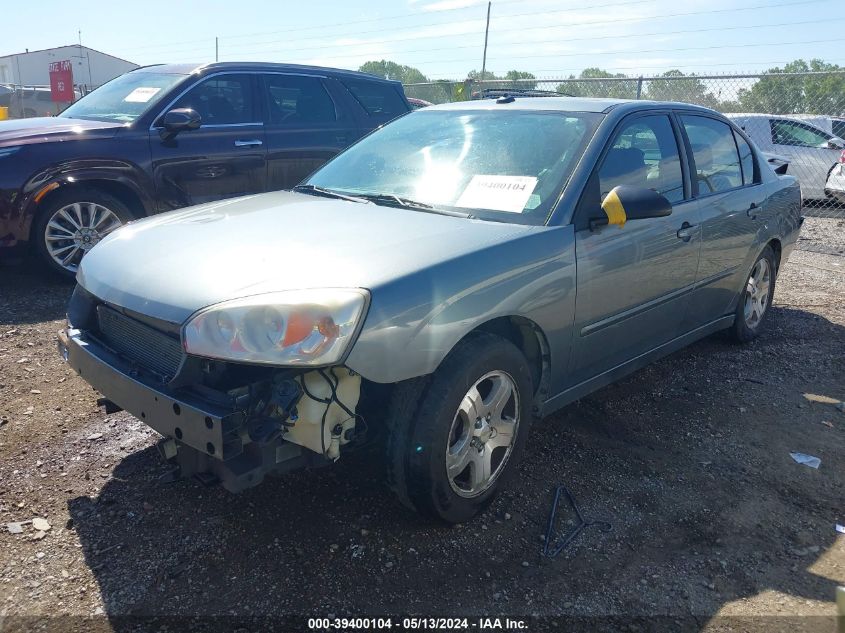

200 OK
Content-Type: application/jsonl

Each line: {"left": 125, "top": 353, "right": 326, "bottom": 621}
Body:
{"left": 725, "top": 114, "right": 845, "bottom": 200}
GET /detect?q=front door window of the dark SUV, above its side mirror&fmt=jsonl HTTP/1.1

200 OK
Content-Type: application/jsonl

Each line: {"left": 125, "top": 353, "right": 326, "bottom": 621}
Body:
{"left": 173, "top": 75, "right": 252, "bottom": 125}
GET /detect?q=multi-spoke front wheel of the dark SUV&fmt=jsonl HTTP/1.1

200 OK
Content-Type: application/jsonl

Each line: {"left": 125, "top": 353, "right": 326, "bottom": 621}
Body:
{"left": 32, "top": 188, "right": 134, "bottom": 279}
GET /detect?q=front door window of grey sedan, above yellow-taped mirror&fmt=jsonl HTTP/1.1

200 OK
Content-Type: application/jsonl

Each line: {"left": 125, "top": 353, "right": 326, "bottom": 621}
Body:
{"left": 599, "top": 115, "right": 684, "bottom": 202}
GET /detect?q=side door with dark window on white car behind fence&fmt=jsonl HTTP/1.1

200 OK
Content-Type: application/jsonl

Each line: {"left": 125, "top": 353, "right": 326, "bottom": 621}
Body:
{"left": 769, "top": 119, "right": 841, "bottom": 200}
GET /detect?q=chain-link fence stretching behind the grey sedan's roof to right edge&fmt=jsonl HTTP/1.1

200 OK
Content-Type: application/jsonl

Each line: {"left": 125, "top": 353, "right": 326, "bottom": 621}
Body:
{"left": 405, "top": 71, "right": 845, "bottom": 217}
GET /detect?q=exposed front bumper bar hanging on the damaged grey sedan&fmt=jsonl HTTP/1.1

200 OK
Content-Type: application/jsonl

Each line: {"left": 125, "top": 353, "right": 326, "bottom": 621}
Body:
{"left": 58, "top": 328, "right": 328, "bottom": 492}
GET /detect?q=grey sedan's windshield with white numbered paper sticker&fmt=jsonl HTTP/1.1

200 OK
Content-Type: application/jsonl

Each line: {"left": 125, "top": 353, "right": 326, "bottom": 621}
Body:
{"left": 306, "top": 110, "right": 601, "bottom": 224}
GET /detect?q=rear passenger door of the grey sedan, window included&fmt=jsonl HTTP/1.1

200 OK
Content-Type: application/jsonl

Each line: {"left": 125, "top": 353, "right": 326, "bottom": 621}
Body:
{"left": 679, "top": 113, "right": 767, "bottom": 327}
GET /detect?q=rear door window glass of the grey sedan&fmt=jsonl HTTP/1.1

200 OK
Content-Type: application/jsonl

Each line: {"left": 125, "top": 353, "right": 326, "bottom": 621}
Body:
{"left": 681, "top": 116, "right": 742, "bottom": 195}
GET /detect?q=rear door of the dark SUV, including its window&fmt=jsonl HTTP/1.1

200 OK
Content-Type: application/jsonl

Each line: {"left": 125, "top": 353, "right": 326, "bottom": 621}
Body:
{"left": 261, "top": 73, "right": 360, "bottom": 191}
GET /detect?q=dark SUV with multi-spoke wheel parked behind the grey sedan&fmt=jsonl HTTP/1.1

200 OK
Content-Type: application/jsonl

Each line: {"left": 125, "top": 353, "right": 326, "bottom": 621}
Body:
{"left": 0, "top": 62, "right": 411, "bottom": 276}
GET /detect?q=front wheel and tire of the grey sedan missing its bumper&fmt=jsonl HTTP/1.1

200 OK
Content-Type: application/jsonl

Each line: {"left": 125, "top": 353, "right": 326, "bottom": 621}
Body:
{"left": 387, "top": 333, "right": 533, "bottom": 523}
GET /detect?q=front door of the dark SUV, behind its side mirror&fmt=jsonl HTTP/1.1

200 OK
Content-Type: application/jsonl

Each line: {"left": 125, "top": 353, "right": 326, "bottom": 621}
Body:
{"left": 150, "top": 73, "right": 267, "bottom": 209}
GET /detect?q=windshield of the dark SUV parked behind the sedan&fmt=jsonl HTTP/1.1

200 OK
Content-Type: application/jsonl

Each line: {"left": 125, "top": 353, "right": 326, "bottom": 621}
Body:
{"left": 59, "top": 72, "right": 185, "bottom": 123}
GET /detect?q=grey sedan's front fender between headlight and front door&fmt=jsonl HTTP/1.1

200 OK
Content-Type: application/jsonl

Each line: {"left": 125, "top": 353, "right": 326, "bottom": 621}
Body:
{"left": 346, "top": 226, "right": 575, "bottom": 385}
